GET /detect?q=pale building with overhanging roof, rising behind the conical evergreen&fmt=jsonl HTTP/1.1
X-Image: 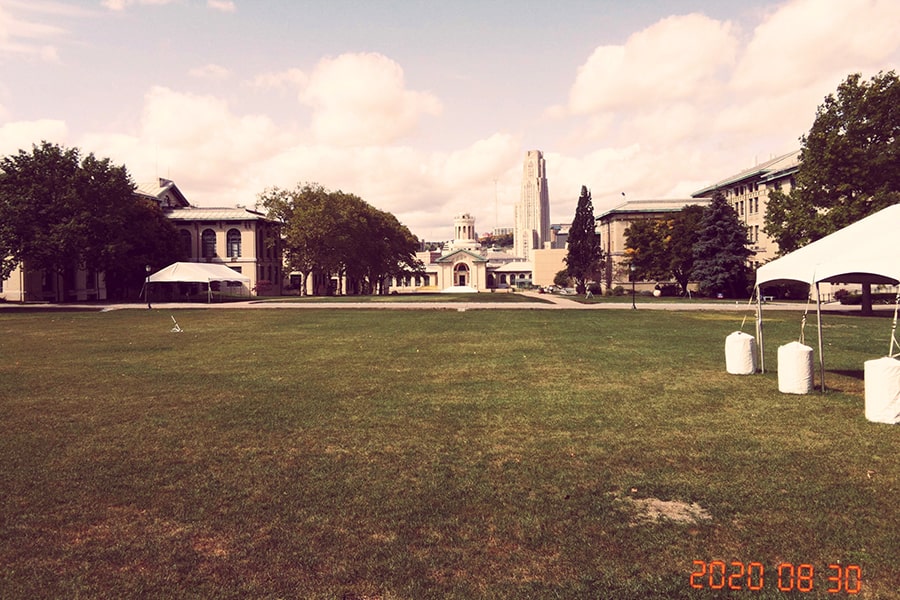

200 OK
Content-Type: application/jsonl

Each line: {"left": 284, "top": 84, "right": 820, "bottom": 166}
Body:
{"left": 691, "top": 150, "right": 800, "bottom": 266}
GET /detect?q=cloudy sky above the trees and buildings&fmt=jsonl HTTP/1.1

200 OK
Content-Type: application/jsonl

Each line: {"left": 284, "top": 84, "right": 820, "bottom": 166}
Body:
{"left": 0, "top": 0, "right": 900, "bottom": 241}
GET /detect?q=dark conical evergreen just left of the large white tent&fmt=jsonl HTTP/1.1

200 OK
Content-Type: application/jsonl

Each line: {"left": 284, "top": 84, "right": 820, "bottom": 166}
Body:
{"left": 692, "top": 192, "right": 753, "bottom": 298}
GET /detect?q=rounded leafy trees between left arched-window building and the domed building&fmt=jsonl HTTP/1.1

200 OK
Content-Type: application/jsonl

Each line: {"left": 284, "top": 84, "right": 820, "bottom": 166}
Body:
{"left": 259, "top": 183, "right": 421, "bottom": 294}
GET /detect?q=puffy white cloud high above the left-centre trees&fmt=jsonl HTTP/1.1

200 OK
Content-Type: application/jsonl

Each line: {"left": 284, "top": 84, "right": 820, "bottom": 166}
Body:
{"left": 300, "top": 53, "right": 442, "bottom": 145}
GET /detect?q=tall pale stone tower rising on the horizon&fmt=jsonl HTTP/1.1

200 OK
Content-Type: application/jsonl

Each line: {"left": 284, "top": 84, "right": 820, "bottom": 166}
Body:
{"left": 513, "top": 150, "right": 550, "bottom": 260}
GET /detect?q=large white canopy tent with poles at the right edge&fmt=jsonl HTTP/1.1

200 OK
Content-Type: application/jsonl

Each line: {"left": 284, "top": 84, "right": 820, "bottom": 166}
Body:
{"left": 756, "top": 204, "right": 900, "bottom": 391}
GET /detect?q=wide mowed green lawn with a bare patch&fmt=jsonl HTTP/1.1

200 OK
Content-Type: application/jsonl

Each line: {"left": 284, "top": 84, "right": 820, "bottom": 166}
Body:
{"left": 0, "top": 308, "right": 900, "bottom": 600}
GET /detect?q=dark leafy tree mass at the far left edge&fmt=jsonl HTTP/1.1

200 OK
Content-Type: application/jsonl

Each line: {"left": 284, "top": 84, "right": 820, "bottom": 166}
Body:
{"left": 0, "top": 142, "right": 179, "bottom": 298}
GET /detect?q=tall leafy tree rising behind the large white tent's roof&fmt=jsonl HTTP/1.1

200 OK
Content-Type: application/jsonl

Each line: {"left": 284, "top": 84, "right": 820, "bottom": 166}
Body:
{"left": 765, "top": 71, "right": 900, "bottom": 253}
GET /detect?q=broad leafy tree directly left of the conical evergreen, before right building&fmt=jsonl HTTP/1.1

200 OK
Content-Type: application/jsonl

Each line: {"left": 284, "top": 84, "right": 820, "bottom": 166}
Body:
{"left": 625, "top": 204, "right": 703, "bottom": 293}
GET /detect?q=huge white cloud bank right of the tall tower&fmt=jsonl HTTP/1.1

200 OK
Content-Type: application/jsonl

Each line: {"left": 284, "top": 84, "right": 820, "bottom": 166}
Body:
{"left": 545, "top": 0, "right": 900, "bottom": 218}
